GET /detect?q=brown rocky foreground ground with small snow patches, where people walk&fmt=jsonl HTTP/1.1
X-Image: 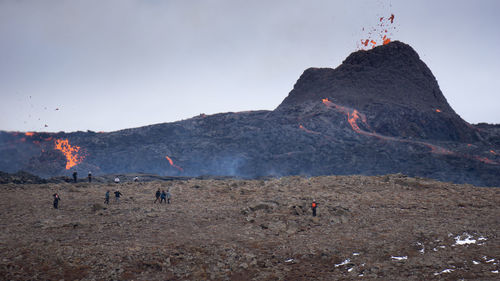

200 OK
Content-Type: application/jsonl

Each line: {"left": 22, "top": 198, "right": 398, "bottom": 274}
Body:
{"left": 0, "top": 174, "right": 500, "bottom": 280}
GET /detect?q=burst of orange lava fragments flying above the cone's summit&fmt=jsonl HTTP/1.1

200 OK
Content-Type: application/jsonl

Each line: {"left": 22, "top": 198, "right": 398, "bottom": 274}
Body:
{"left": 358, "top": 14, "right": 396, "bottom": 50}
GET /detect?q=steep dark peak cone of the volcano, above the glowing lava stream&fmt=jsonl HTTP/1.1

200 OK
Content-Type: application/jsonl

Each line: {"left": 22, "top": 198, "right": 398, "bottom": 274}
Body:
{"left": 276, "top": 41, "right": 477, "bottom": 142}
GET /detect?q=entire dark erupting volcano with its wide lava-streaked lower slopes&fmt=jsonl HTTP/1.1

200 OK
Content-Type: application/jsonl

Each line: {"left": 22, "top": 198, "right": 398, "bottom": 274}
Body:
{"left": 0, "top": 41, "right": 500, "bottom": 186}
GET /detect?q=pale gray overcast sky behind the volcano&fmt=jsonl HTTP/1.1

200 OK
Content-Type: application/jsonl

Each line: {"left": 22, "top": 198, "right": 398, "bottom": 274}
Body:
{"left": 0, "top": 0, "right": 500, "bottom": 132}
